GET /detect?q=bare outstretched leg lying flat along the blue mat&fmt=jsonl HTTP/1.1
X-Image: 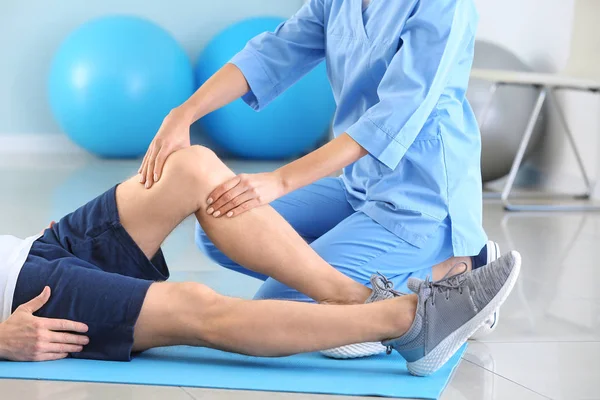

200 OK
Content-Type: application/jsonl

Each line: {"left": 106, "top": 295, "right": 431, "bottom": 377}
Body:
{"left": 133, "top": 283, "right": 417, "bottom": 357}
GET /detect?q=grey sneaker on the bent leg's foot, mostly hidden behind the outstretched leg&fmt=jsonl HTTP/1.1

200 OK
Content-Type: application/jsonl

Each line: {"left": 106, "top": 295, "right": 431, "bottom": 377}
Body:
{"left": 321, "top": 274, "right": 404, "bottom": 359}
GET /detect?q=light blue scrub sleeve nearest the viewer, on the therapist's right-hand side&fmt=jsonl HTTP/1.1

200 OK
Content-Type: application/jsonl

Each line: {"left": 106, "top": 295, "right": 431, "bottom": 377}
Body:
{"left": 348, "top": 0, "right": 477, "bottom": 169}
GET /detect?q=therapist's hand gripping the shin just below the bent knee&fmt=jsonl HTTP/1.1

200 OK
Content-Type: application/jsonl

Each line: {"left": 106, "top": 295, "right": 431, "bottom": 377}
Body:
{"left": 206, "top": 172, "right": 285, "bottom": 218}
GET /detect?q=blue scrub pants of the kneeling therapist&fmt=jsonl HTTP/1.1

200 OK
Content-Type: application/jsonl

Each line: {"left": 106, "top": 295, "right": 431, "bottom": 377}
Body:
{"left": 196, "top": 178, "right": 453, "bottom": 302}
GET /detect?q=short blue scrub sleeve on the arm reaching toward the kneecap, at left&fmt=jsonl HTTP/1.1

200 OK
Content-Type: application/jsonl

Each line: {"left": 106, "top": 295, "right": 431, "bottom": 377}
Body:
{"left": 230, "top": 0, "right": 327, "bottom": 111}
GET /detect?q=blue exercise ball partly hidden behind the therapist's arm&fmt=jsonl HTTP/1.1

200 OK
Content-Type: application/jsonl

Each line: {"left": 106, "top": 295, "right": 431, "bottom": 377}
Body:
{"left": 196, "top": 18, "right": 336, "bottom": 159}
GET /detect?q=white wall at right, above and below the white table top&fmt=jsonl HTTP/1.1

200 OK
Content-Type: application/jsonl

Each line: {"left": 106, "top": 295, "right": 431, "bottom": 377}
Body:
{"left": 475, "top": 0, "right": 600, "bottom": 197}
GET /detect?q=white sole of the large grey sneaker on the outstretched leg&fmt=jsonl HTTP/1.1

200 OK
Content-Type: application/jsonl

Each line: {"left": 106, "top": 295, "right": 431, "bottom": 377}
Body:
{"left": 407, "top": 251, "right": 521, "bottom": 376}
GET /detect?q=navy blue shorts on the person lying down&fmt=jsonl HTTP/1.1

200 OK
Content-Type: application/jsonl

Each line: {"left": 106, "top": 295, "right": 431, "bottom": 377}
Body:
{"left": 13, "top": 187, "right": 169, "bottom": 361}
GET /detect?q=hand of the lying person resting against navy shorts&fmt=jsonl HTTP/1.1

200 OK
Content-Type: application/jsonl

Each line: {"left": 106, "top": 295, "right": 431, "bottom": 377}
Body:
{"left": 0, "top": 286, "right": 89, "bottom": 361}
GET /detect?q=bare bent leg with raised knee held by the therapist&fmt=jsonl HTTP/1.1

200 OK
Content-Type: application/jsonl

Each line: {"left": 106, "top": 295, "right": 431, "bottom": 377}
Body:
{"left": 117, "top": 146, "right": 370, "bottom": 304}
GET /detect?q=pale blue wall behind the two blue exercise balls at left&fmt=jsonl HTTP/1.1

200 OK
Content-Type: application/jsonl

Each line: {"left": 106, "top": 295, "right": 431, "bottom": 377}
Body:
{"left": 0, "top": 0, "right": 302, "bottom": 135}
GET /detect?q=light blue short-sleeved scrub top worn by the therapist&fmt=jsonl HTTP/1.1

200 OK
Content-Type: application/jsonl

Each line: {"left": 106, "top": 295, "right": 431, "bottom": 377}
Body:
{"left": 231, "top": 0, "right": 486, "bottom": 256}
